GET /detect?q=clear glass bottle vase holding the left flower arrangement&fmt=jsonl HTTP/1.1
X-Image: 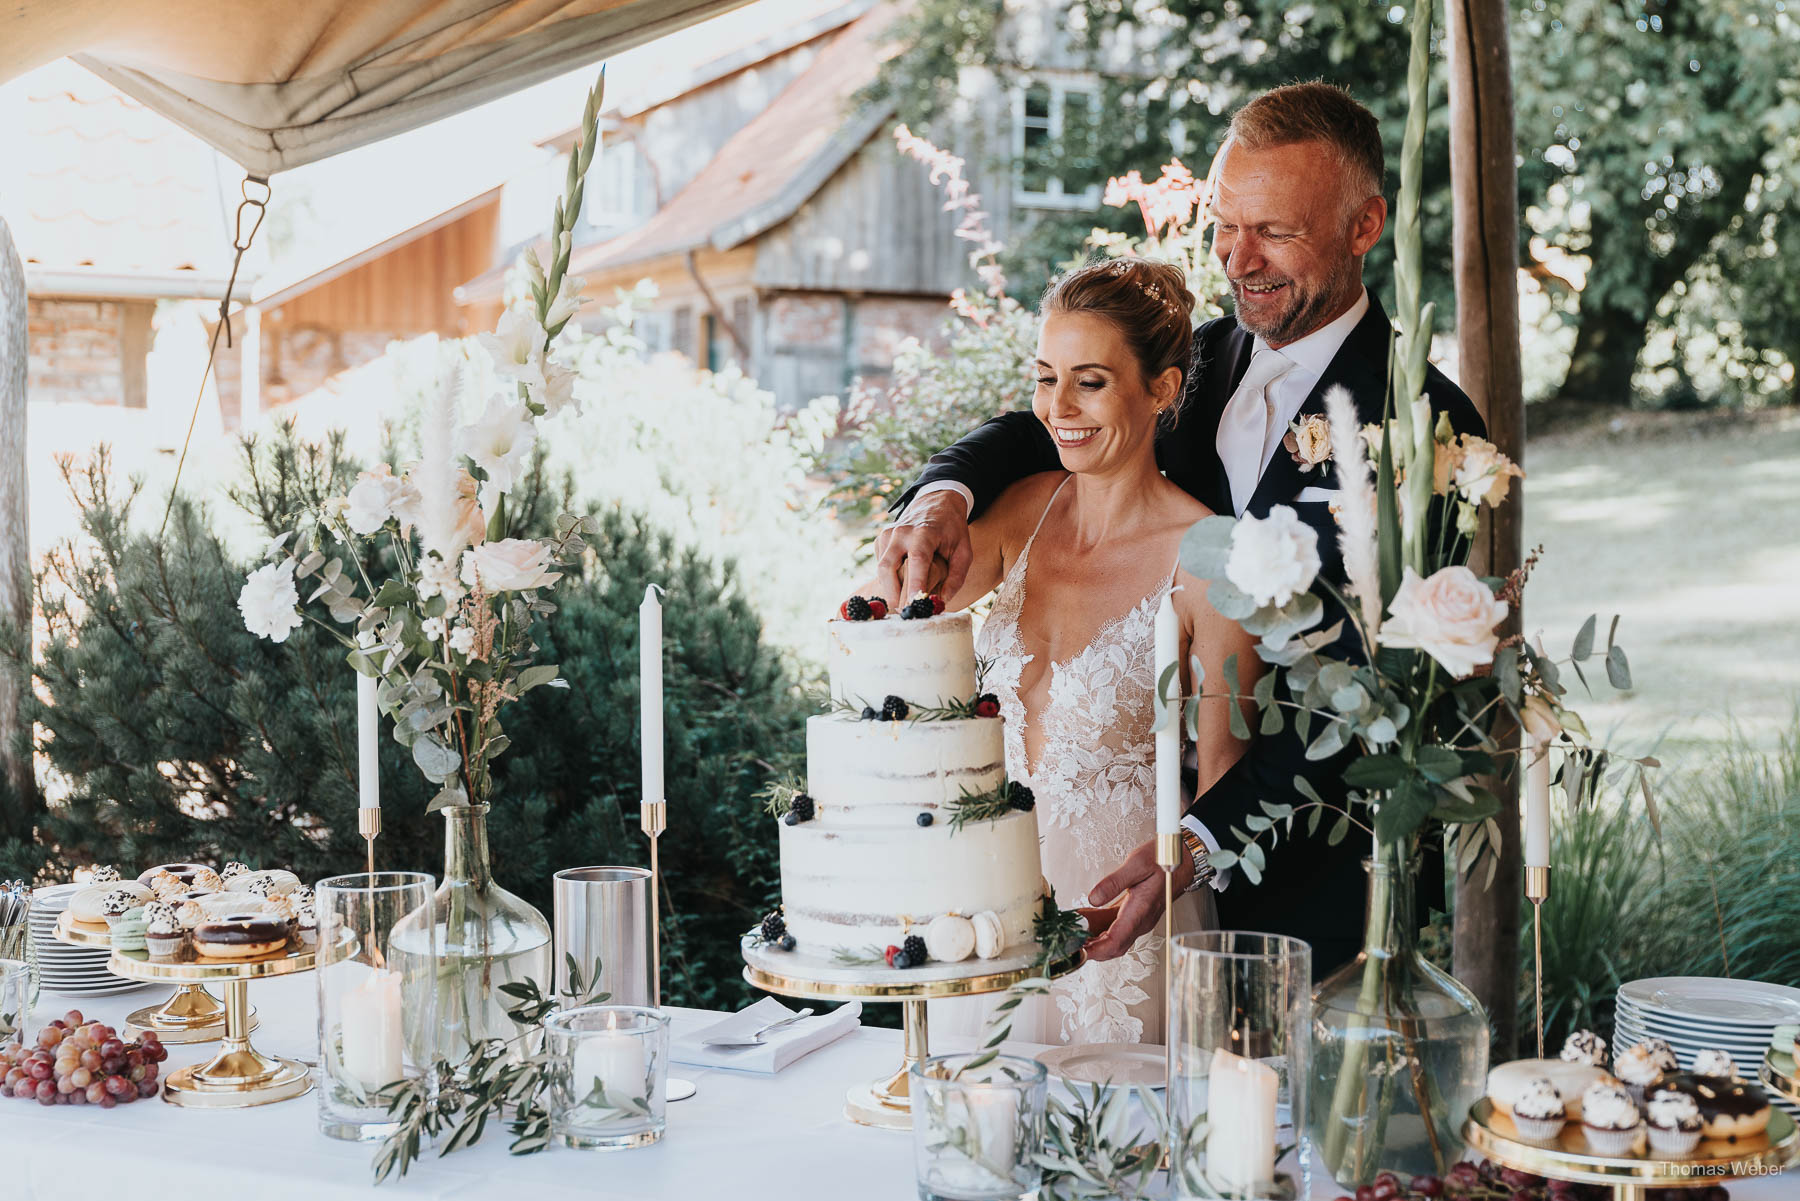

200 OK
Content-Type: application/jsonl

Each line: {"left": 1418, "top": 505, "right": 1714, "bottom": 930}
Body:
{"left": 432, "top": 805, "right": 556, "bottom": 1062}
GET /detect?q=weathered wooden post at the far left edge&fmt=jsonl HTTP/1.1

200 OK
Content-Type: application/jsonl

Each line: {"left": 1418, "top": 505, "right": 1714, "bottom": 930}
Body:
{"left": 0, "top": 216, "right": 38, "bottom": 839}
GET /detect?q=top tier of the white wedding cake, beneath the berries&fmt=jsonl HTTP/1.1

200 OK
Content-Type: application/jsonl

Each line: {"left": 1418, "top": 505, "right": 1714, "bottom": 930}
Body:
{"left": 824, "top": 612, "right": 976, "bottom": 709}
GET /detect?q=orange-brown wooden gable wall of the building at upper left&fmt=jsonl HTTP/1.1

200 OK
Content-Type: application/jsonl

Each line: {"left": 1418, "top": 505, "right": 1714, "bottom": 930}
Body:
{"left": 265, "top": 205, "right": 499, "bottom": 337}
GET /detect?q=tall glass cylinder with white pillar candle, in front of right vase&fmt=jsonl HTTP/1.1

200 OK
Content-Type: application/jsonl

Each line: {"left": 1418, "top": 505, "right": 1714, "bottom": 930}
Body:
{"left": 1168, "top": 931, "right": 1312, "bottom": 1201}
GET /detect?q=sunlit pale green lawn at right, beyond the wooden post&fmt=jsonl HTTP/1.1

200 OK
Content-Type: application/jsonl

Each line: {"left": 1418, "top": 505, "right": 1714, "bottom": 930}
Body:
{"left": 1525, "top": 412, "right": 1800, "bottom": 751}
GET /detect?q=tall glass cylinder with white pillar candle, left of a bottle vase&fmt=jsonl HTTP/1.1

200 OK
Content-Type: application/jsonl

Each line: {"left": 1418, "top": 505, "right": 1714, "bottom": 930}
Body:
{"left": 313, "top": 871, "right": 437, "bottom": 1142}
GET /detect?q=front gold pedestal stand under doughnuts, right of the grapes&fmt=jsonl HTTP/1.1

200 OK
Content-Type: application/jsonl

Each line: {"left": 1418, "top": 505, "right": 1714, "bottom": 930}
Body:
{"left": 106, "top": 938, "right": 325, "bottom": 1109}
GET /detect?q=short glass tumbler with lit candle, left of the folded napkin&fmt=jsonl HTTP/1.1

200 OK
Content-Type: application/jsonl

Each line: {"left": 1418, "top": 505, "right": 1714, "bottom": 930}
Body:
{"left": 544, "top": 1005, "right": 670, "bottom": 1151}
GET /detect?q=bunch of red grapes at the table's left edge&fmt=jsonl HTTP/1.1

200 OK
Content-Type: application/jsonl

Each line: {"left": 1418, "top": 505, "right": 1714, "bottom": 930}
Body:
{"left": 0, "top": 1008, "right": 169, "bottom": 1109}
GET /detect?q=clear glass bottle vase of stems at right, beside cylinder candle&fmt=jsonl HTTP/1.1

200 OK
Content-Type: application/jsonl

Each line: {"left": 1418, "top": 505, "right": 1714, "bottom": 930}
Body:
{"left": 1309, "top": 844, "right": 1489, "bottom": 1188}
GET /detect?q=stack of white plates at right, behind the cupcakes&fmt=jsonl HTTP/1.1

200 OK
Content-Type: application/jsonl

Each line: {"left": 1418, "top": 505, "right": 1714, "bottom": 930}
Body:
{"left": 1613, "top": 976, "right": 1800, "bottom": 1118}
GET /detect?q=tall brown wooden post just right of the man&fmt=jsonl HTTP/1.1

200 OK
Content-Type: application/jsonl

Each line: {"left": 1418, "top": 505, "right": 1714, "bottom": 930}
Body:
{"left": 1444, "top": 0, "right": 1525, "bottom": 1059}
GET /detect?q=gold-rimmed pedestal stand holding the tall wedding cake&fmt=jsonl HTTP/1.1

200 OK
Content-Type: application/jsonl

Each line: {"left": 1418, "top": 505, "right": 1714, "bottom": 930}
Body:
{"left": 743, "top": 942, "right": 1082, "bottom": 1131}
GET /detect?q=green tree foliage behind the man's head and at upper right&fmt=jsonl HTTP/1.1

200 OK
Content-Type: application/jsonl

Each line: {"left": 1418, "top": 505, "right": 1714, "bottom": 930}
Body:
{"left": 878, "top": 0, "right": 1800, "bottom": 403}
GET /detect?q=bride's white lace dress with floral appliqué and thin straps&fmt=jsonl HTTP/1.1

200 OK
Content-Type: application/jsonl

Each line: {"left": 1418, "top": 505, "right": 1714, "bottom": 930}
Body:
{"left": 931, "top": 481, "right": 1211, "bottom": 1044}
